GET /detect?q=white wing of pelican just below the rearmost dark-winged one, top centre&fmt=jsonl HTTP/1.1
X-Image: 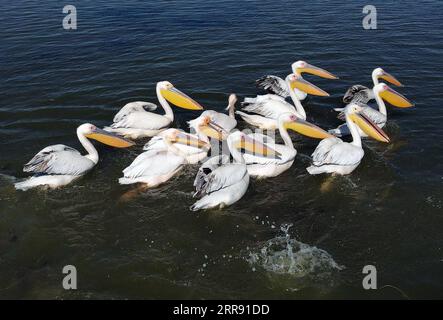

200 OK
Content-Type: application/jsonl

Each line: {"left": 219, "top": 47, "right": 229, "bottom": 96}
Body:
{"left": 242, "top": 94, "right": 298, "bottom": 119}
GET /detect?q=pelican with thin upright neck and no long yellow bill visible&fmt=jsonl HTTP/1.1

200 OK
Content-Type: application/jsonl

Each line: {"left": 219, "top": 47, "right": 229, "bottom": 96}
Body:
{"left": 188, "top": 93, "right": 241, "bottom": 133}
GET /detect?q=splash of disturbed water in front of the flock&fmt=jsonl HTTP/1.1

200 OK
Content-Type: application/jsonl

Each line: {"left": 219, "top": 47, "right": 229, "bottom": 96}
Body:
{"left": 247, "top": 224, "right": 344, "bottom": 287}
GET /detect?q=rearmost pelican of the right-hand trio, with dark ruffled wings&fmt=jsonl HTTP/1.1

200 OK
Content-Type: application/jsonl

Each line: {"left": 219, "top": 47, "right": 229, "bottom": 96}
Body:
{"left": 344, "top": 68, "right": 403, "bottom": 104}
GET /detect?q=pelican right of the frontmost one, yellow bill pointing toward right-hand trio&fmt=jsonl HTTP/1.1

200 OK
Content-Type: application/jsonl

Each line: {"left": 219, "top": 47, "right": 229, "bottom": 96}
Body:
{"left": 244, "top": 113, "right": 332, "bottom": 178}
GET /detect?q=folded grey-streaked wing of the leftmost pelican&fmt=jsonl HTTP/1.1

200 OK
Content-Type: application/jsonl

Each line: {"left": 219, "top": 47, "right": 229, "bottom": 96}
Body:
{"left": 23, "top": 144, "right": 95, "bottom": 176}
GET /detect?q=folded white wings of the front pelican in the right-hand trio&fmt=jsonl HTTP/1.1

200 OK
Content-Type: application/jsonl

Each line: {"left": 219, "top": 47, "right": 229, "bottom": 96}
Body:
{"left": 312, "top": 138, "right": 363, "bottom": 167}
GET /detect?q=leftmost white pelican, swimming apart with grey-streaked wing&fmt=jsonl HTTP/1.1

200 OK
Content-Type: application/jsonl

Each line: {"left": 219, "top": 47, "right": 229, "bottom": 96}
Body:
{"left": 15, "top": 123, "right": 134, "bottom": 190}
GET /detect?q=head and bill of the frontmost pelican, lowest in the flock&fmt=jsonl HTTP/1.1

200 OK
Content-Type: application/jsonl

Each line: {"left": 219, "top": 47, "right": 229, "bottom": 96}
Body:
{"left": 227, "top": 131, "right": 281, "bottom": 159}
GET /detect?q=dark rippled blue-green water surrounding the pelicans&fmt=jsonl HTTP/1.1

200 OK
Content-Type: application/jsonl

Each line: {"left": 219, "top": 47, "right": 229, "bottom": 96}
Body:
{"left": 0, "top": 0, "right": 443, "bottom": 299}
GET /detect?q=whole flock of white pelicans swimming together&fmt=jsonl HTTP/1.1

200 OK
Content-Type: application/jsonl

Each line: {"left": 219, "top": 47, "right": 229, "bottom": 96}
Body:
{"left": 15, "top": 61, "right": 413, "bottom": 210}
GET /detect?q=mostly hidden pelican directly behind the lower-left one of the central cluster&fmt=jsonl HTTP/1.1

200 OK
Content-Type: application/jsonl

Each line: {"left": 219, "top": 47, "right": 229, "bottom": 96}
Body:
{"left": 143, "top": 116, "right": 227, "bottom": 164}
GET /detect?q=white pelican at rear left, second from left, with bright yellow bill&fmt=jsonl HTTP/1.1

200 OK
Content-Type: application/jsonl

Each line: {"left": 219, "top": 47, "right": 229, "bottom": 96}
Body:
{"left": 105, "top": 81, "right": 203, "bottom": 139}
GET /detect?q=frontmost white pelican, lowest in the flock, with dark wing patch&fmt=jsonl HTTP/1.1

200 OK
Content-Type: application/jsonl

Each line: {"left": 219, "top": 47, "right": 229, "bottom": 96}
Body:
{"left": 190, "top": 131, "right": 279, "bottom": 211}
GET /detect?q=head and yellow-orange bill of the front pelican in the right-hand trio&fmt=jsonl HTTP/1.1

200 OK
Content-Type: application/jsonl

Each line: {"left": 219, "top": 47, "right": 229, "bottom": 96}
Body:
{"left": 344, "top": 103, "right": 390, "bottom": 142}
